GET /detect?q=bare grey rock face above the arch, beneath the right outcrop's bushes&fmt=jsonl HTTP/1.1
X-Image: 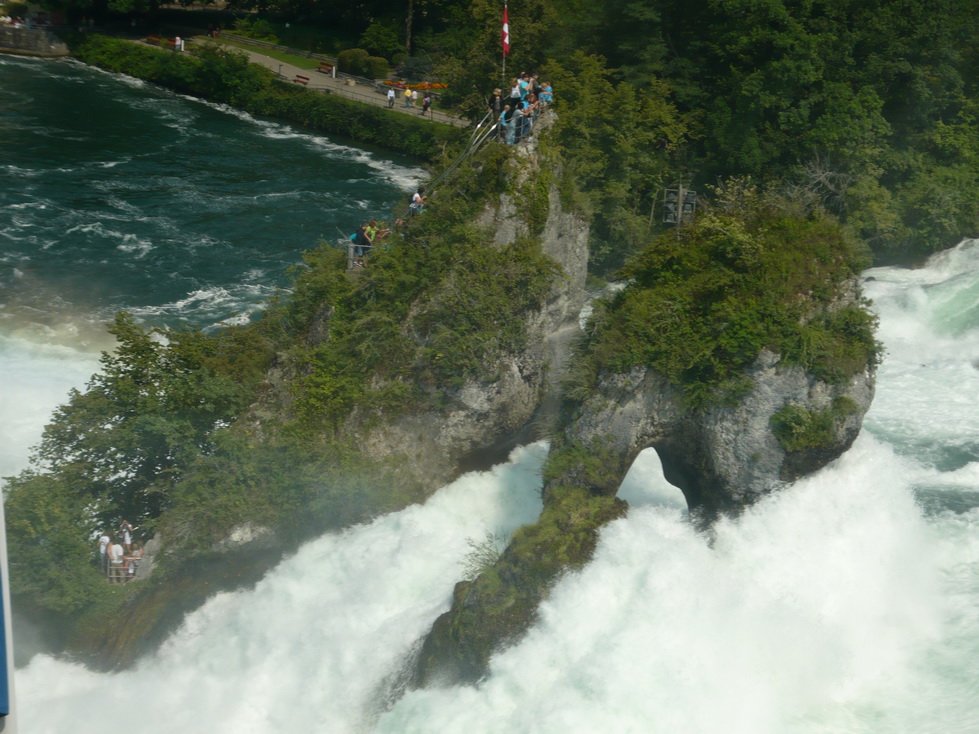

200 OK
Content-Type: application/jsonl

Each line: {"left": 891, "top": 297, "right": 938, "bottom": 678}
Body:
{"left": 566, "top": 344, "right": 874, "bottom": 517}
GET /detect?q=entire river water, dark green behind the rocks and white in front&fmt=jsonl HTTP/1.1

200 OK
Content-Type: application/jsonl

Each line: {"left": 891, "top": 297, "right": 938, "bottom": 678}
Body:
{"left": 0, "top": 57, "right": 979, "bottom": 734}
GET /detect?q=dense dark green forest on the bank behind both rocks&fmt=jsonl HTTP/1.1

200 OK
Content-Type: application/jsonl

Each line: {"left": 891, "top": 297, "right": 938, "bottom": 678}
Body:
{"left": 50, "top": 0, "right": 979, "bottom": 268}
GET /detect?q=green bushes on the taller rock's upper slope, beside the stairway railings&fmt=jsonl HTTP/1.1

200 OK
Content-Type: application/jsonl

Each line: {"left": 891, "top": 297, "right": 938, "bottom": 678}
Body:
{"left": 287, "top": 143, "right": 556, "bottom": 425}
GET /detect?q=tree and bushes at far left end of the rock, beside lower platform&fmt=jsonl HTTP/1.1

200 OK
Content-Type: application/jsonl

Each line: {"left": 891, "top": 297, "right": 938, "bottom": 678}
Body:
{"left": 6, "top": 314, "right": 270, "bottom": 614}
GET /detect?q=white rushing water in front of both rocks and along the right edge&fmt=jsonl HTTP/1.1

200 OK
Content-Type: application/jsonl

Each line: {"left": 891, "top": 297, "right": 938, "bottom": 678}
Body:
{"left": 7, "top": 241, "right": 979, "bottom": 734}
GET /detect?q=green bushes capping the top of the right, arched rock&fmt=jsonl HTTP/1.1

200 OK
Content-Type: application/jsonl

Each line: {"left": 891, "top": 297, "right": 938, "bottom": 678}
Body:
{"left": 572, "top": 182, "right": 879, "bottom": 404}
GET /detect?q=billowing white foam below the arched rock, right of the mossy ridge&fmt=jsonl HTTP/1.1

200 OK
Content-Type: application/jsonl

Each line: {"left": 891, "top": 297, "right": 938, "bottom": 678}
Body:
{"left": 376, "top": 439, "right": 947, "bottom": 734}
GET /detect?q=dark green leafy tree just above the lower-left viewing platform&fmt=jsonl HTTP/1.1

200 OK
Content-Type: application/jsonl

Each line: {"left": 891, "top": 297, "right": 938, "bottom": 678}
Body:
{"left": 35, "top": 313, "right": 266, "bottom": 524}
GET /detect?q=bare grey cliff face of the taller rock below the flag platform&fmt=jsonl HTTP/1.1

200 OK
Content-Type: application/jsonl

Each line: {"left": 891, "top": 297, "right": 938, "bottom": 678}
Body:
{"left": 345, "top": 136, "right": 588, "bottom": 498}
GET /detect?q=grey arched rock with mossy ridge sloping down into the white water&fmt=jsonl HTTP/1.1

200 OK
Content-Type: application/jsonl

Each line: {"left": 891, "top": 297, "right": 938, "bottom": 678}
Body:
{"left": 413, "top": 284, "right": 875, "bottom": 685}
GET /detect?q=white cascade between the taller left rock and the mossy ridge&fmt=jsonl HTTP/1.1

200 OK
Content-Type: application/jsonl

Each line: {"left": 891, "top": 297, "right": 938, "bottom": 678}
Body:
{"left": 18, "top": 445, "right": 546, "bottom": 734}
